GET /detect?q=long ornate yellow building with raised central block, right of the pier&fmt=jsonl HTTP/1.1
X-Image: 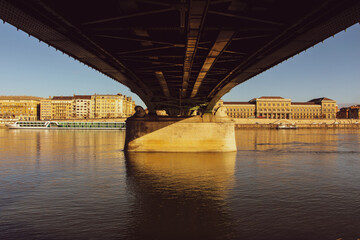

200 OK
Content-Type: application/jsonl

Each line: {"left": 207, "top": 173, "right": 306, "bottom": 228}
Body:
{"left": 215, "top": 96, "right": 337, "bottom": 119}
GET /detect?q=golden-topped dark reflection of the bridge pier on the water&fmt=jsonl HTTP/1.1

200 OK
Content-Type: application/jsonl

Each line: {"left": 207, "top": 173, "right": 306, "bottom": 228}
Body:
{"left": 126, "top": 153, "right": 236, "bottom": 239}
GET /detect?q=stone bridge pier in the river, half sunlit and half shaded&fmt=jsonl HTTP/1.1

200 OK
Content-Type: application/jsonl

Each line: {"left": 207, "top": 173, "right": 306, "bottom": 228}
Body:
{"left": 125, "top": 114, "right": 236, "bottom": 152}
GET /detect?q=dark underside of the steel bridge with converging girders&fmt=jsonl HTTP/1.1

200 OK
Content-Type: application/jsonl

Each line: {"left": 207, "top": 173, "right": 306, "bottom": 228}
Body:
{"left": 0, "top": 0, "right": 360, "bottom": 152}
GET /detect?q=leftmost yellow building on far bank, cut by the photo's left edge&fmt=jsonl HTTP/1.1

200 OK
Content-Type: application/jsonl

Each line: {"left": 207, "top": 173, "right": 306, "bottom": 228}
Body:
{"left": 0, "top": 96, "right": 41, "bottom": 121}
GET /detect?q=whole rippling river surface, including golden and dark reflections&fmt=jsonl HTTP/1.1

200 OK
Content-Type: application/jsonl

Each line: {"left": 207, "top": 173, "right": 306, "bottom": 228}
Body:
{"left": 0, "top": 129, "right": 360, "bottom": 240}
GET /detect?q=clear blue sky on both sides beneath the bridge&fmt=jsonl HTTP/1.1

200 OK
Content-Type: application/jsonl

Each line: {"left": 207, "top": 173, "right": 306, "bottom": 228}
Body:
{"left": 0, "top": 21, "right": 360, "bottom": 105}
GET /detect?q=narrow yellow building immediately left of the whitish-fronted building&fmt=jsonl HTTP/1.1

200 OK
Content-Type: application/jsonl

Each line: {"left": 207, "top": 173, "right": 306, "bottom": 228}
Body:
{"left": 51, "top": 96, "right": 74, "bottom": 120}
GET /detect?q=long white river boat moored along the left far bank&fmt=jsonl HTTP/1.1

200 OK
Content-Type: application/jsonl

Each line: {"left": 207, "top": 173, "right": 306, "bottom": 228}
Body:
{"left": 5, "top": 121, "right": 126, "bottom": 130}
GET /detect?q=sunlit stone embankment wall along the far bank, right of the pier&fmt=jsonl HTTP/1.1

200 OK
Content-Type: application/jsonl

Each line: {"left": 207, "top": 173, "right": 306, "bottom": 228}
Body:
{"left": 234, "top": 118, "right": 360, "bottom": 129}
